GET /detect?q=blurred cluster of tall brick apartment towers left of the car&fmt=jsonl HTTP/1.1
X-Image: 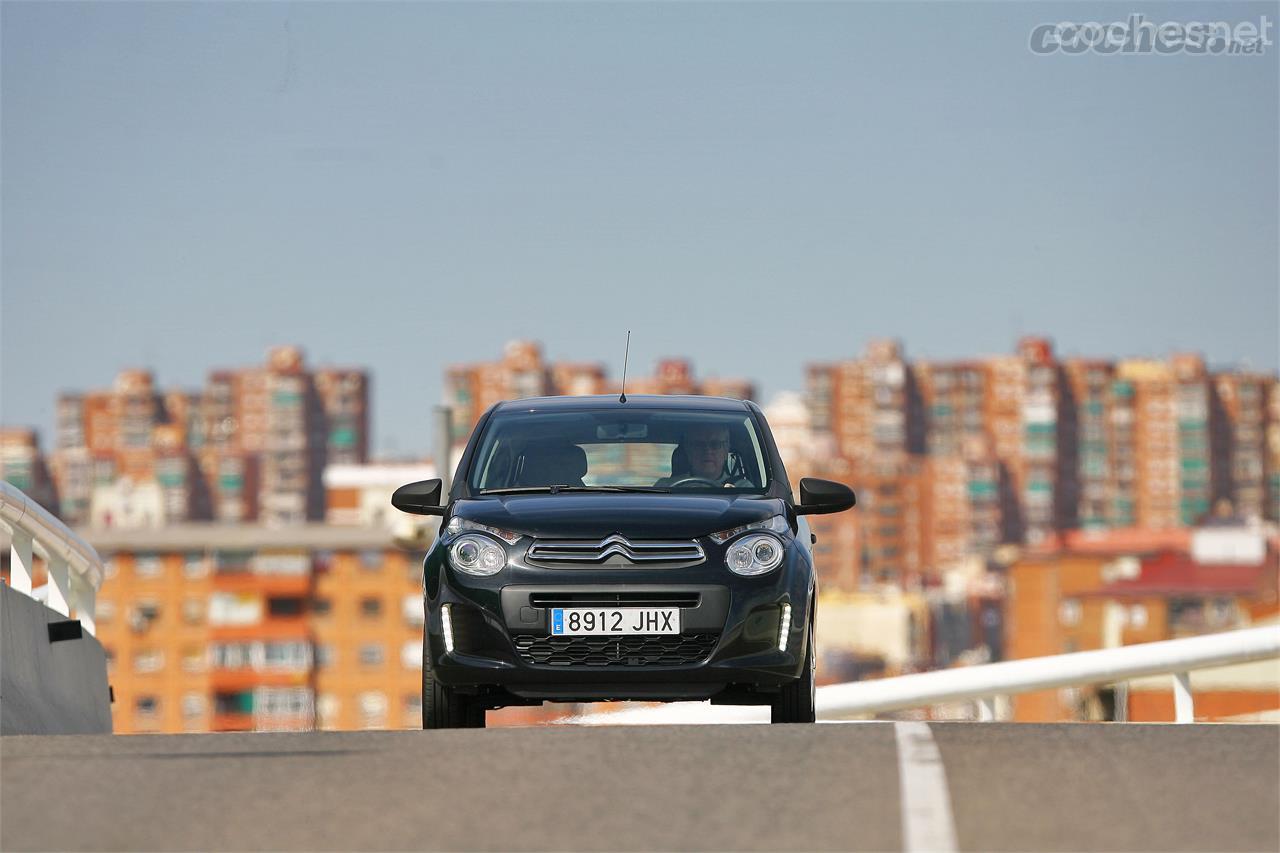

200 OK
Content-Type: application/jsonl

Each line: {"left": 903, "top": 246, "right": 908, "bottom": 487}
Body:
{"left": 52, "top": 347, "right": 369, "bottom": 525}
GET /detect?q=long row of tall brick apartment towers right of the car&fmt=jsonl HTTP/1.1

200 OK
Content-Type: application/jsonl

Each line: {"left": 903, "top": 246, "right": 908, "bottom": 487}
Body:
{"left": 805, "top": 338, "right": 1280, "bottom": 574}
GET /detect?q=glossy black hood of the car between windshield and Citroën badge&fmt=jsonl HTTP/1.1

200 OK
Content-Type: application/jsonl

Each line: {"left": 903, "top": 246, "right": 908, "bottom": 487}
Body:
{"left": 453, "top": 493, "right": 785, "bottom": 539}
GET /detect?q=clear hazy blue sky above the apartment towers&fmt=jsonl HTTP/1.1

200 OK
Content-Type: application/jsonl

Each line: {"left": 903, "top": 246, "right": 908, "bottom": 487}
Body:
{"left": 0, "top": 3, "right": 1280, "bottom": 453}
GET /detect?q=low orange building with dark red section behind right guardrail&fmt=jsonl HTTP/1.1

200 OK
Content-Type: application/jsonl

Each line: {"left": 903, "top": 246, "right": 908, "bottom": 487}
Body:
{"left": 1005, "top": 523, "right": 1280, "bottom": 721}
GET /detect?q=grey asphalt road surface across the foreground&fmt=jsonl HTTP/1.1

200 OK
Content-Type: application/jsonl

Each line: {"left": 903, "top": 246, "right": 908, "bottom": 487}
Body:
{"left": 0, "top": 722, "right": 1280, "bottom": 852}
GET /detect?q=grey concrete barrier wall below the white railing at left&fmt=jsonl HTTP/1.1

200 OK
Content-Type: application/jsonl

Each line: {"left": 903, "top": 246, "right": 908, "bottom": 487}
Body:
{"left": 0, "top": 583, "right": 111, "bottom": 735}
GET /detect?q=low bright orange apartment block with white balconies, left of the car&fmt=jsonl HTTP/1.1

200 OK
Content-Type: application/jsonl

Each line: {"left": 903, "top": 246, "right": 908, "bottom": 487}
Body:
{"left": 87, "top": 524, "right": 422, "bottom": 733}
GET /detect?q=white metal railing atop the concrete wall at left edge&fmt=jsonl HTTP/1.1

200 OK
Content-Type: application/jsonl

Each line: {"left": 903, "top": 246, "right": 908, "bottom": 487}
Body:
{"left": 0, "top": 480, "right": 104, "bottom": 634}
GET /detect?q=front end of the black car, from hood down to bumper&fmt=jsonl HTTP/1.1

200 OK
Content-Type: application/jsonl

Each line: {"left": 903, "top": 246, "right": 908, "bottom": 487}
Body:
{"left": 424, "top": 494, "right": 814, "bottom": 707}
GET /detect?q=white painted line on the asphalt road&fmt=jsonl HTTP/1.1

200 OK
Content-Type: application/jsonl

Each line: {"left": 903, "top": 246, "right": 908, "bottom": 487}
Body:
{"left": 893, "top": 722, "right": 957, "bottom": 853}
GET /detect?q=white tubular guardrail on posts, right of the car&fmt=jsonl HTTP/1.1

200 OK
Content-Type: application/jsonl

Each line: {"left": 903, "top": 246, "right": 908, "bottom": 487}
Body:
{"left": 818, "top": 625, "right": 1280, "bottom": 722}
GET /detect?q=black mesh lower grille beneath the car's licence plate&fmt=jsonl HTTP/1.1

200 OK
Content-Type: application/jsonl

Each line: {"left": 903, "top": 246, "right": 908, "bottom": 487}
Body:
{"left": 515, "top": 634, "right": 719, "bottom": 666}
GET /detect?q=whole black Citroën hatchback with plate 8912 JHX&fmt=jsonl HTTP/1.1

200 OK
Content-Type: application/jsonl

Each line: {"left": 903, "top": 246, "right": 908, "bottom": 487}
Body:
{"left": 392, "top": 396, "right": 854, "bottom": 729}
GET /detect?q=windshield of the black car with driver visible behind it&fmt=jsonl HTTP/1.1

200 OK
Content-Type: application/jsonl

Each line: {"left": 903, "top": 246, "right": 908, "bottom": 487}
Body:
{"left": 468, "top": 409, "right": 769, "bottom": 493}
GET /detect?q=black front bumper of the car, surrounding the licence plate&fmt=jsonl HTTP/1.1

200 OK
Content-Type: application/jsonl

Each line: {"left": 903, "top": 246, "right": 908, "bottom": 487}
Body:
{"left": 424, "top": 542, "right": 814, "bottom": 704}
